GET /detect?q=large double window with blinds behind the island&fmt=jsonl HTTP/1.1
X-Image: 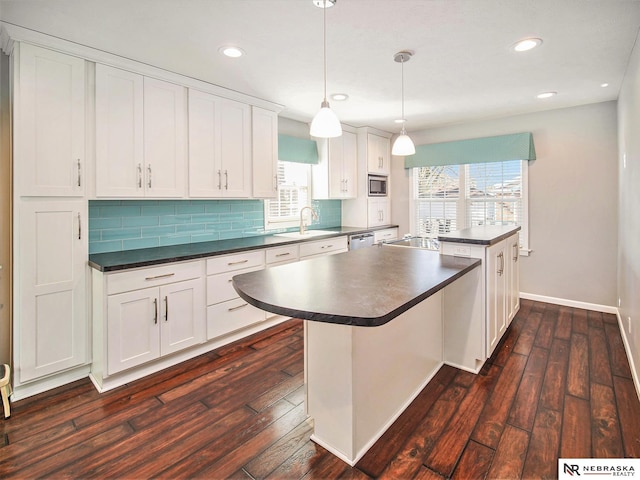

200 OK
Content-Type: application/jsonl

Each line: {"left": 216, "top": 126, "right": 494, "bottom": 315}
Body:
{"left": 411, "top": 160, "right": 528, "bottom": 251}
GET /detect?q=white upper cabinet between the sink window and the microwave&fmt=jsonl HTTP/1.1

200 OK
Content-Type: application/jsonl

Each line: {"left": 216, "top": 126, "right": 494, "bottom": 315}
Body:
{"left": 312, "top": 130, "right": 358, "bottom": 199}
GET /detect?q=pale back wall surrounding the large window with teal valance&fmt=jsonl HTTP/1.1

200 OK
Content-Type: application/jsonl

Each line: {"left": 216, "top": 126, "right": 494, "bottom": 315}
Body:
{"left": 391, "top": 102, "right": 620, "bottom": 307}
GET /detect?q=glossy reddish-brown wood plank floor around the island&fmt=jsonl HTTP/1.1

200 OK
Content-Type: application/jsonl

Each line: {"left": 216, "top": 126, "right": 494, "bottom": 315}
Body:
{"left": 0, "top": 301, "right": 640, "bottom": 479}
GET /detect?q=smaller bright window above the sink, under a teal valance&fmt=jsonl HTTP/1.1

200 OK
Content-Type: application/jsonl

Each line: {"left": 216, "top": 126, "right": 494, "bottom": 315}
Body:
{"left": 264, "top": 161, "right": 311, "bottom": 229}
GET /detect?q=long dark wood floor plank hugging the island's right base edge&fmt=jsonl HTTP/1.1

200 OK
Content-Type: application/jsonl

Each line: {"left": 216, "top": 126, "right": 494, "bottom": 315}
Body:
{"left": 357, "top": 369, "right": 445, "bottom": 477}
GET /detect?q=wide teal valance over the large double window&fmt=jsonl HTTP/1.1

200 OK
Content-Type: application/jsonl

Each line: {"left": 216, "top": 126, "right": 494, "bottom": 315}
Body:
{"left": 404, "top": 132, "right": 536, "bottom": 168}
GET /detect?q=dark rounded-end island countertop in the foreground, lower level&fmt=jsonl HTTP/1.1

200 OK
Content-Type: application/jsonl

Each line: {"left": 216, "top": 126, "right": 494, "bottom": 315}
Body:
{"left": 233, "top": 246, "right": 481, "bottom": 327}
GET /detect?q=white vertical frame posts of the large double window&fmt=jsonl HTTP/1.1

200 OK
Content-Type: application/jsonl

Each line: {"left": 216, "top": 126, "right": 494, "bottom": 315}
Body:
{"left": 409, "top": 160, "right": 531, "bottom": 257}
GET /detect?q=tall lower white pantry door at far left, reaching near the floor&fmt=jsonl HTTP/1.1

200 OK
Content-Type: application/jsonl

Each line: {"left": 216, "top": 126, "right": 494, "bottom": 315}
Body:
{"left": 14, "top": 200, "right": 88, "bottom": 382}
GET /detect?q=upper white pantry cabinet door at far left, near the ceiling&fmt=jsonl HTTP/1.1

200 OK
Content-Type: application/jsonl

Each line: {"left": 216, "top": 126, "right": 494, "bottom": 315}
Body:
{"left": 14, "top": 43, "right": 85, "bottom": 197}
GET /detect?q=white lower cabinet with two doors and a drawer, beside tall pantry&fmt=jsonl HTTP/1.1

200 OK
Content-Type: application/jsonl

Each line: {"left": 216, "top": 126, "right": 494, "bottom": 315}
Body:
{"left": 106, "top": 262, "right": 206, "bottom": 375}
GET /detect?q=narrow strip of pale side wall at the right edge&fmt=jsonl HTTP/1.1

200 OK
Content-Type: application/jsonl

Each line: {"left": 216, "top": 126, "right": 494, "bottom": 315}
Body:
{"left": 617, "top": 33, "right": 640, "bottom": 391}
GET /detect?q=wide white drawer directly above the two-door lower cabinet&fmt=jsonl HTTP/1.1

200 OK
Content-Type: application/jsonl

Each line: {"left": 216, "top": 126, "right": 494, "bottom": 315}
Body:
{"left": 106, "top": 260, "right": 204, "bottom": 295}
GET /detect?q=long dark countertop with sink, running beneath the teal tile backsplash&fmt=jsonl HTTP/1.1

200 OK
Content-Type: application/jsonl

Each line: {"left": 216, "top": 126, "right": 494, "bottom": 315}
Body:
{"left": 89, "top": 225, "right": 397, "bottom": 272}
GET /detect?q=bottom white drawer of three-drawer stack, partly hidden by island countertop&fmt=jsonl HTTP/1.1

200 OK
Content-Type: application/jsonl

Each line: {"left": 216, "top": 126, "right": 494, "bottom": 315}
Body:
{"left": 207, "top": 298, "right": 266, "bottom": 340}
